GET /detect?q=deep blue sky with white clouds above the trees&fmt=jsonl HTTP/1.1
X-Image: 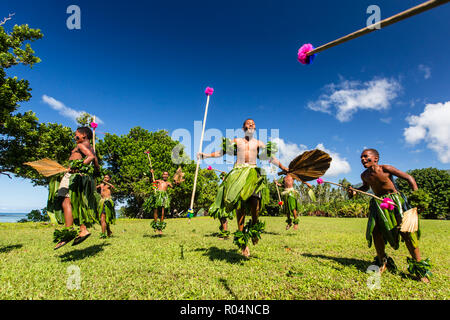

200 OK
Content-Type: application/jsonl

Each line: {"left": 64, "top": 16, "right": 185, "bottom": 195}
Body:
{"left": 0, "top": 0, "right": 450, "bottom": 212}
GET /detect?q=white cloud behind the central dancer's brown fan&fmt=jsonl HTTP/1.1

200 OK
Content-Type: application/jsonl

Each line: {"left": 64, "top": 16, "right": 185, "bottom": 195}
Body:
{"left": 272, "top": 138, "right": 351, "bottom": 177}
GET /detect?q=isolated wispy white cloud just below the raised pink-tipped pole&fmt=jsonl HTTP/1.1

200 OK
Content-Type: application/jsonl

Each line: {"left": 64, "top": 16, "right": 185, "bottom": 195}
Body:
{"left": 308, "top": 78, "right": 401, "bottom": 122}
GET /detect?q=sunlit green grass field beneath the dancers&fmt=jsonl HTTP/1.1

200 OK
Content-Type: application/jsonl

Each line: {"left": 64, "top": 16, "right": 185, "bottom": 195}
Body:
{"left": 0, "top": 217, "right": 450, "bottom": 300}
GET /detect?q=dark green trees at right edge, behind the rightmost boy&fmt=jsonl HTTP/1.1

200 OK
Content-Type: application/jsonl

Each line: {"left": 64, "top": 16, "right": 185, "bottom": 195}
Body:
{"left": 396, "top": 168, "right": 450, "bottom": 219}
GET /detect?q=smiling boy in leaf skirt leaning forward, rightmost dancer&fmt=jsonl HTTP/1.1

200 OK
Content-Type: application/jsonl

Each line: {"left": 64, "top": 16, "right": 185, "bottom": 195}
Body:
{"left": 349, "top": 149, "right": 431, "bottom": 282}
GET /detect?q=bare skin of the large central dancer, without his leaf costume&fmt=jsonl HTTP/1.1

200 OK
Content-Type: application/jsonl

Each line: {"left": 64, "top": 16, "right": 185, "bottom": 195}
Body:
{"left": 197, "top": 119, "right": 289, "bottom": 257}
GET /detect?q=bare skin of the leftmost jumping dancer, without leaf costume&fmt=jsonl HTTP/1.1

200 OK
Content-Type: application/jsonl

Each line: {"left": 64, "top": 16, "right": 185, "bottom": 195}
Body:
{"left": 56, "top": 130, "right": 100, "bottom": 248}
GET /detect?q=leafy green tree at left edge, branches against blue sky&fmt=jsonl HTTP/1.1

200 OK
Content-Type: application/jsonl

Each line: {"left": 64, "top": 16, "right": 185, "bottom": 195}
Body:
{"left": 0, "top": 25, "right": 73, "bottom": 185}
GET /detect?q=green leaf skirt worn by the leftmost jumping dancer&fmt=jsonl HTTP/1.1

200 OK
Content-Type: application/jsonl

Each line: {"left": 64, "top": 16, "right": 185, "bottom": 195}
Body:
{"left": 47, "top": 173, "right": 98, "bottom": 227}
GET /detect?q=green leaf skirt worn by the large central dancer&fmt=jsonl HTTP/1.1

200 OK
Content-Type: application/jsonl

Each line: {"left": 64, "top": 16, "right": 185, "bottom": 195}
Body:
{"left": 209, "top": 166, "right": 270, "bottom": 218}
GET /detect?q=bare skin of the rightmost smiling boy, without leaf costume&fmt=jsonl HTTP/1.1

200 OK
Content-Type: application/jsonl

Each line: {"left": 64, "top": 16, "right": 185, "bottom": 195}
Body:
{"left": 349, "top": 150, "right": 429, "bottom": 282}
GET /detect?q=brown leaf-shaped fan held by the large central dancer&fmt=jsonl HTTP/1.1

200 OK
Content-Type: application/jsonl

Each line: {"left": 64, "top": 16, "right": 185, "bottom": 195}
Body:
{"left": 278, "top": 149, "right": 332, "bottom": 181}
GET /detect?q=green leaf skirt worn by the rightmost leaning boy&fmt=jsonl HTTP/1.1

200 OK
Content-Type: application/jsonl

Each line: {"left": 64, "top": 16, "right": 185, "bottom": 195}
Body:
{"left": 366, "top": 193, "right": 420, "bottom": 250}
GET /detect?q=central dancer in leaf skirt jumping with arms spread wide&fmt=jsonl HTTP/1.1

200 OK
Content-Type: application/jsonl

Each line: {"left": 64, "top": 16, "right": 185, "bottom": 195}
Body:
{"left": 198, "top": 119, "right": 288, "bottom": 257}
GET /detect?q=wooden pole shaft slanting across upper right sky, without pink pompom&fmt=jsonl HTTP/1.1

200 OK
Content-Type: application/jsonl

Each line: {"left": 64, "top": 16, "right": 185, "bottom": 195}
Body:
{"left": 306, "top": 0, "right": 450, "bottom": 56}
